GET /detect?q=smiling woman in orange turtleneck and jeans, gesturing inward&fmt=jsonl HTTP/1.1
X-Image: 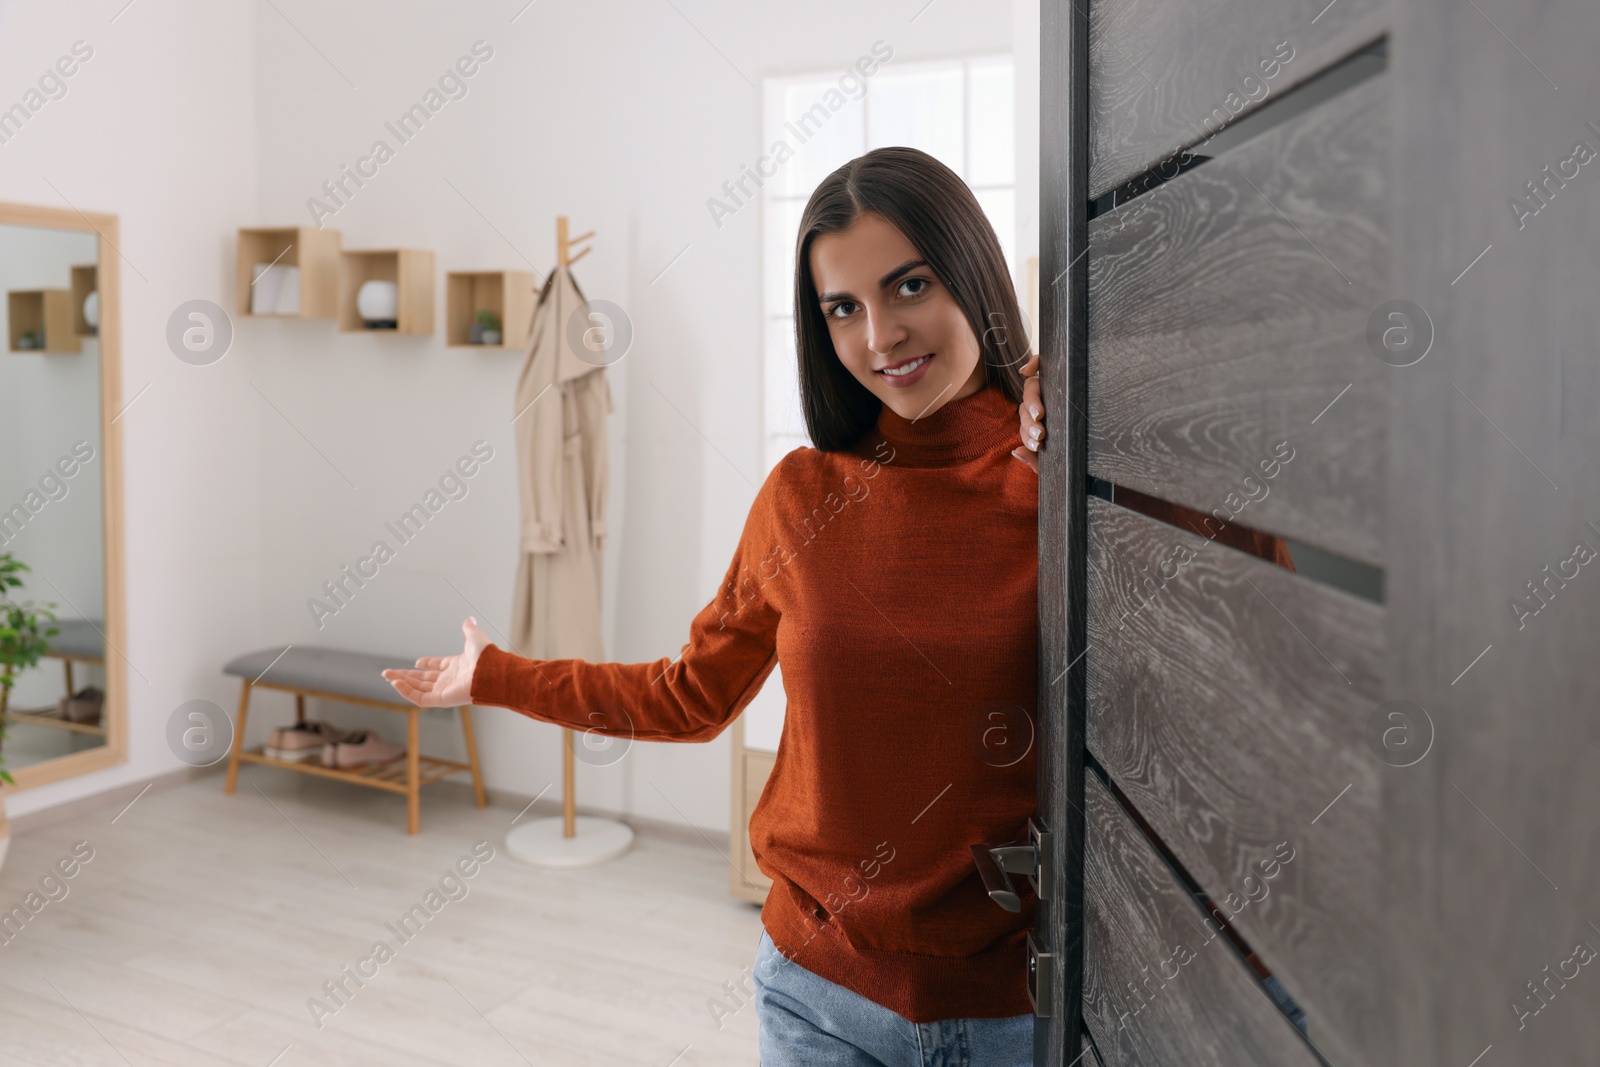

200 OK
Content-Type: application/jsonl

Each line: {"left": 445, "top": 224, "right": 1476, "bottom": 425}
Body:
{"left": 384, "top": 147, "right": 1043, "bottom": 1067}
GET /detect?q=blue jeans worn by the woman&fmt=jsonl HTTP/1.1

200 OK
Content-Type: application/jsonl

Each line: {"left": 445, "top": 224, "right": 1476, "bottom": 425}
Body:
{"left": 752, "top": 929, "right": 1034, "bottom": 1067}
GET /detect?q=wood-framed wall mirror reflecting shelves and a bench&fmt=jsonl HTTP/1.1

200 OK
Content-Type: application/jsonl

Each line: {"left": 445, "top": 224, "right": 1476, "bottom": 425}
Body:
{"left": 0, "top": 203, "right": 126, "bottom": 789}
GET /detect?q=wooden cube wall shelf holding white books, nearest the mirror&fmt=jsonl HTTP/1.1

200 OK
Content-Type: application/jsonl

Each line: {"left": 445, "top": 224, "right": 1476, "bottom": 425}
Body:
{"left": 237, "top": 226, "right": 341, "bottom": 318}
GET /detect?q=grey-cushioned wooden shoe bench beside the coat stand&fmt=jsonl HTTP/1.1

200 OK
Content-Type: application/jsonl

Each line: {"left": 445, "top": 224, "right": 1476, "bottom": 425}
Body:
{"left": 222, "top": 645, "right": 488, "bottom": 833}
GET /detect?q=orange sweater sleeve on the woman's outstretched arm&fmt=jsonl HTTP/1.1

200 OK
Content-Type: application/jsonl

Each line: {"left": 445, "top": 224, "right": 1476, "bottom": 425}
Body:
{"left": 472, "top": 464, "right": 787, "bottom": 741}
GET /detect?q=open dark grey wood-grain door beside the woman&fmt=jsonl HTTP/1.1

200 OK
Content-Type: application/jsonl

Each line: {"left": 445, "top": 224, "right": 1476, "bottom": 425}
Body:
{"left": 1037, "top": 0, "right": 1600, "bottom": 1067}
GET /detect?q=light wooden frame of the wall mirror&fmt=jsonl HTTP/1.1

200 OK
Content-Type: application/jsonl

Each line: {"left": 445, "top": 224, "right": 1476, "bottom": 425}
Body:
{"left": 0, "top": 202, "right": 128, "bottom": 793}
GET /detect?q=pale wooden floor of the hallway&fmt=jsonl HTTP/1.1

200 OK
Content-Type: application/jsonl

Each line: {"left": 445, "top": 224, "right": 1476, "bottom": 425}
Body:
{"left": 0, "top": 766, "right": 762, "bottom": 1067}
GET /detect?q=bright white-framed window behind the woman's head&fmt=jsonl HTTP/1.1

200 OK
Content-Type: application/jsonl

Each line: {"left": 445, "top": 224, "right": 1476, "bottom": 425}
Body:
{"left": 762, "top": 56, "right": 1019, "bottom": 474}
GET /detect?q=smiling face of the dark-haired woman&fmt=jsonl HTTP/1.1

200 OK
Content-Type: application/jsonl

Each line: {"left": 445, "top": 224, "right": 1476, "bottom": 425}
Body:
{"left": 811, "top": 213, "right": 984, "bottom": 419}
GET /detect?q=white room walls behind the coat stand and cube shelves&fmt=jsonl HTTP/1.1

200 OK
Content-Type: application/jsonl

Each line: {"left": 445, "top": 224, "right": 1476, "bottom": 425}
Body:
{"left": 0, "top": 0, "right": 1011, "bottom": 832}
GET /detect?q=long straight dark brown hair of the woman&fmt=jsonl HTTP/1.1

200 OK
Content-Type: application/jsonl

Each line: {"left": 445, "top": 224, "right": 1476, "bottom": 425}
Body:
{"left": 795, "top": 147, "right": 1029, "bottom": 451}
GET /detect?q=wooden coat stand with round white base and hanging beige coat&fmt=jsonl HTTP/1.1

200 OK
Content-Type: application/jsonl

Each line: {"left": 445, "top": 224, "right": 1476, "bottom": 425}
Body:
{"left": 506, "top": 216, "right": 634, "bottom": 867}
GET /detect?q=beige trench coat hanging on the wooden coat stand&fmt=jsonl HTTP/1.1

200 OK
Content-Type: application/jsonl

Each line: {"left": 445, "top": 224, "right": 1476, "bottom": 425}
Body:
{"left": 510, "top": 266, "right": 613, "bottom": 662}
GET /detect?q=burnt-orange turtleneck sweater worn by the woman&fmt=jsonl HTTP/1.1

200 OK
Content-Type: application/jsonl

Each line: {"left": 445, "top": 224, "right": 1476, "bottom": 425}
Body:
{"left": 472, "top": 386, "right": 1038, "bottom": 1022}
